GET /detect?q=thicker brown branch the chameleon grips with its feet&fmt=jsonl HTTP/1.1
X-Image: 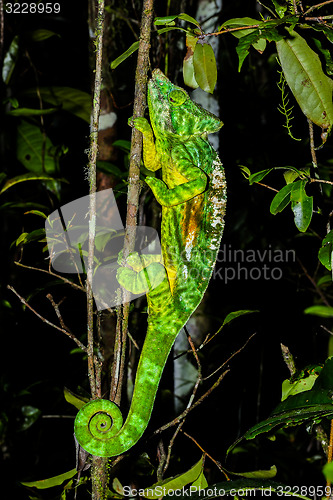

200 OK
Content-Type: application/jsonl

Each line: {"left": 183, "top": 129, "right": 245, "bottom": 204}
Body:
{"left": 111, "top": 0, "right": 153, "bottom": 404}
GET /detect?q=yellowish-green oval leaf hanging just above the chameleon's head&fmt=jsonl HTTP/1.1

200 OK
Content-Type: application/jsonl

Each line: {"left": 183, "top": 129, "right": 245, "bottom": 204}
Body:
{"left": 193, "top": 43, "right": 217, "bottom": 94}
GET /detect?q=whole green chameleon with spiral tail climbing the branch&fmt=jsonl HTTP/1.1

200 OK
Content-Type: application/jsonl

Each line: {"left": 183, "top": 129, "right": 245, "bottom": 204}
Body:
{"left": 74, "top": 69, "right": 226, "bottom": 457}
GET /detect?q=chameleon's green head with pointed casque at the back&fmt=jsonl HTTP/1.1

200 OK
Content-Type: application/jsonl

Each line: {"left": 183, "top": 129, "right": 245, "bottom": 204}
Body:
{"left": 148, "top": 69, "right": 223, "bottom": 137}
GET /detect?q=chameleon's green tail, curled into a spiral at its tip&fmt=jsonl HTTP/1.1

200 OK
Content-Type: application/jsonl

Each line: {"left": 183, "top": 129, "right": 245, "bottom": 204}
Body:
{"left": 74, "top": 300, "right": 180, "bottom": 457}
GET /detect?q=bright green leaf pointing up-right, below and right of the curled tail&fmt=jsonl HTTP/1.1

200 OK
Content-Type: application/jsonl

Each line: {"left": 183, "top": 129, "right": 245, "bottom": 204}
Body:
{"left": 142, "top": 457, "right": 204, "bottom": 499}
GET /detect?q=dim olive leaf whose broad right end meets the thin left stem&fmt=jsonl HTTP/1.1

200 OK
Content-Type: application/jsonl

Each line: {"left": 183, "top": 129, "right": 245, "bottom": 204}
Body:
{"left": 23, "top": 87, "right": 92, "bottom": 123}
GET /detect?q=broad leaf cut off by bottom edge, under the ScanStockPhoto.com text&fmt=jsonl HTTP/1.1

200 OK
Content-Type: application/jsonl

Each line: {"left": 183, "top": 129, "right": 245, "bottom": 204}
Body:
{"left": 164, "top": 479, "right": 310, "bottom": 500}
